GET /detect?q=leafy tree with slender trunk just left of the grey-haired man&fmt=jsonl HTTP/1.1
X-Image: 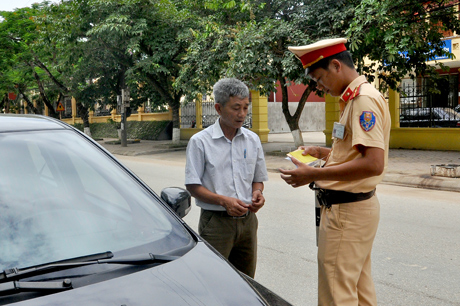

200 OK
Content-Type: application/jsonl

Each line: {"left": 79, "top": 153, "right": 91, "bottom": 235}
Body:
{"left": 77, "top": 0, "right": 198, "bottom": 141}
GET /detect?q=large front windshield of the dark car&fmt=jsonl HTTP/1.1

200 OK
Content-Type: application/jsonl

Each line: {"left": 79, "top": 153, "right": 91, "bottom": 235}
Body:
{"left": 0, "top": 130, "right": 193, "bottom": 271}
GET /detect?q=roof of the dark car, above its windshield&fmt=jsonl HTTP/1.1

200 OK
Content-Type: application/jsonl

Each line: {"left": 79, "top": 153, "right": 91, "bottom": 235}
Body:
{"left": 0, "top": 114, "right": 68, "bottom": 133}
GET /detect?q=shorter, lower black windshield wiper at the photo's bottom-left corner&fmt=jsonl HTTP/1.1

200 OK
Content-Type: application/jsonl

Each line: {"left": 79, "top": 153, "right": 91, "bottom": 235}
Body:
{"left": 0, "top": 278, "right": 72, "bottom": 296}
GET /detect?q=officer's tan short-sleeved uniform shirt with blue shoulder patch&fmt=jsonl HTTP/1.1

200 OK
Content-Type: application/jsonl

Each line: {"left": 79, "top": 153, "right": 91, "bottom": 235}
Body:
{"left": 315, "top": 76, "right": 391, "bottom": 193}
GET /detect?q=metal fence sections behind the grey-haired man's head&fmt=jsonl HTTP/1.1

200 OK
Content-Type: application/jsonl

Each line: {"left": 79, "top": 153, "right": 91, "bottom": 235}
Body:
{"left": 180, "top": 102, "right": 252, "bottom": 128}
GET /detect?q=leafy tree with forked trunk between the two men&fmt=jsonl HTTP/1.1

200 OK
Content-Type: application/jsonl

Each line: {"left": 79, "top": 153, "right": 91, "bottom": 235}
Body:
{"left": 179, "top": 0, "right": 356, "bottom": 146}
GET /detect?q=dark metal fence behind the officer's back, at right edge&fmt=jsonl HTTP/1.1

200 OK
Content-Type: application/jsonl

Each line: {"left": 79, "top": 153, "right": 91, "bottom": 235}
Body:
{"left": 399, "top": 75, "right": 460, "bottom": 128}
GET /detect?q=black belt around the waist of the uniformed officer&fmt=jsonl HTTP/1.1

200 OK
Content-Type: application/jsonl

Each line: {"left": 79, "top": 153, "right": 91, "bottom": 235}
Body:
{"left": 310, "top": 183, "right": 375, "bottom": 208}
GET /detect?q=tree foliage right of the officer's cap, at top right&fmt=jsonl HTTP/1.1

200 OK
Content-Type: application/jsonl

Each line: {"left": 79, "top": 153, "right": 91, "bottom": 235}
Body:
{"left": 346, "top": 0, "right": 460, "bottom": 93}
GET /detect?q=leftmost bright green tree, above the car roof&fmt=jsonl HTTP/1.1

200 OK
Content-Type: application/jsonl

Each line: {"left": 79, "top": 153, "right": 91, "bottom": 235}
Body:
{"left": 0, "top": 1, "right": 83, "bottom": 118}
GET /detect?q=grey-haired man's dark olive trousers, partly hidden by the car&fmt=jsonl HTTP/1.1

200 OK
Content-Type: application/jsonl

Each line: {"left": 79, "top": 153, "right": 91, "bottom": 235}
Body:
{"left": 198, "top": 209, "right": 258, "bottom": 278}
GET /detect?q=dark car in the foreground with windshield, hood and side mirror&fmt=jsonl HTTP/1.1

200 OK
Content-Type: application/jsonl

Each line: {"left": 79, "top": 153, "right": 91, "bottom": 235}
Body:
{"left": 0, "top": 115, "right": 290, "bottom": 306}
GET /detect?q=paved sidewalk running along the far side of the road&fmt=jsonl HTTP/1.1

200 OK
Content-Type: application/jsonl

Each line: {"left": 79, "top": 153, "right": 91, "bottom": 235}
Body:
{"left": 98, "top": 132, "right": 460, "bottom": 192}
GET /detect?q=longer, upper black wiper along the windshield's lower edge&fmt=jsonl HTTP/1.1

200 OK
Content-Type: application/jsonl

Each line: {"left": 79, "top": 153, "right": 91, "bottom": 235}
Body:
{"left": 0, "top": 252, "right": 180, "bottom": 283}
